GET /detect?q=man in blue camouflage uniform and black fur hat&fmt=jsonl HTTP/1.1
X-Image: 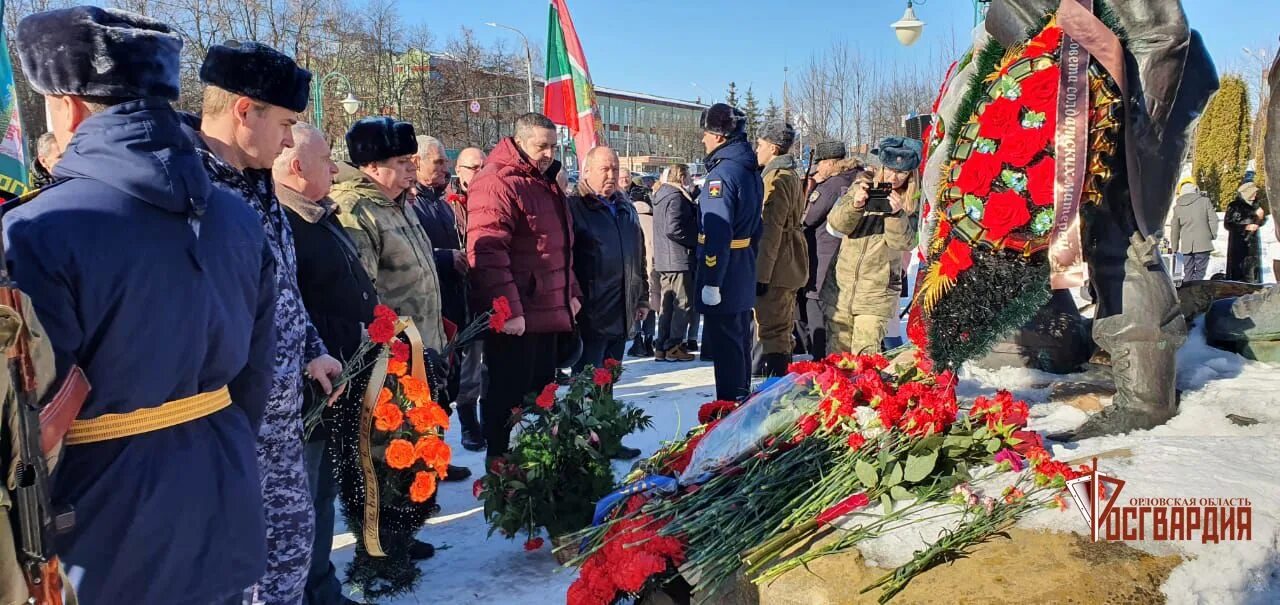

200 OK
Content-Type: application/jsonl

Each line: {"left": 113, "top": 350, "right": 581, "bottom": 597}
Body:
{"left": 188, "top": 41, "right": 342, "bottom": 605}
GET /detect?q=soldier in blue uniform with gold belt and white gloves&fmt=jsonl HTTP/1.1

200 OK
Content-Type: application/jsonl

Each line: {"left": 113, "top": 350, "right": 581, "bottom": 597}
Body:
{"left": 698, "top": 102, "right": 764, "bottom": 400}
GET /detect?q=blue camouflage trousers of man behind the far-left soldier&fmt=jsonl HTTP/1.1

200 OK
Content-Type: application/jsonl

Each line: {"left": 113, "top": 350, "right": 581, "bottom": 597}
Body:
{"left": 257, "top": 372, "right": 315, "bottom": 605}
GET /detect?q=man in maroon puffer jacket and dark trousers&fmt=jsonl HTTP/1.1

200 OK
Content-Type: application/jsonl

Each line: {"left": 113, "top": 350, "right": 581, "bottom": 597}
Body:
{"left": 467, "top": 114, "right": 582, "bottom": 460}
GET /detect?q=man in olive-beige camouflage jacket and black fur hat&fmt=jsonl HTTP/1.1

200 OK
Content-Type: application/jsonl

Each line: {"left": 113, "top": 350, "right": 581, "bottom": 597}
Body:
{"left": 329, "top": 118, "right": 445, "bottom": 350}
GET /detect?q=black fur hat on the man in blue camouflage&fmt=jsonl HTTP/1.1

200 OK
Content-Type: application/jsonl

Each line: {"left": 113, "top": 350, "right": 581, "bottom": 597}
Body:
{"left": 200, "top": 40, "right": 311, "bottom": 111}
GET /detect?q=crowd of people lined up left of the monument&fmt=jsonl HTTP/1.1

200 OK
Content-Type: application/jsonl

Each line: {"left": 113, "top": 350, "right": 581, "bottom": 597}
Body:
{"left": 4, "top": 6, "right": 936, "bottom": 605}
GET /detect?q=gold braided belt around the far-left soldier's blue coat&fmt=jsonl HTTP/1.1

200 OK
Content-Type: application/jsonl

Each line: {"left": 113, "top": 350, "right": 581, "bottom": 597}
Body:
{"left": 67, "top": 386, "right": 232, "bottom": 445}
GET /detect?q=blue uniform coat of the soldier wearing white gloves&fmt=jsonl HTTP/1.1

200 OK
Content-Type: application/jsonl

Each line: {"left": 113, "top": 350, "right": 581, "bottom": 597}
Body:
{"left": 695, "top": 139, "right": 764, "bottom": 315}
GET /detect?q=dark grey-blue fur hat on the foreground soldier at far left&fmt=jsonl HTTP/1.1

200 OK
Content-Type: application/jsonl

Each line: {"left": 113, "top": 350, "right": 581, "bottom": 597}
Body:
{"left": 14, "top": 6, "right": 182, "bottom": 101}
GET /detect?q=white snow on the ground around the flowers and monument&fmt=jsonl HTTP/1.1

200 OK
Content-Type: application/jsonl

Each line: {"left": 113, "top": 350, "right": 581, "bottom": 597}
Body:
{"left": 333, "top": 218, "right": 1280, "bottom": 605}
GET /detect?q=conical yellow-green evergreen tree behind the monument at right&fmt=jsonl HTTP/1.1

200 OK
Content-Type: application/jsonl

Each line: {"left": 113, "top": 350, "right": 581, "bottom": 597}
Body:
{"left": 1193, "top": 75, "right": 1252, "bottom": 210}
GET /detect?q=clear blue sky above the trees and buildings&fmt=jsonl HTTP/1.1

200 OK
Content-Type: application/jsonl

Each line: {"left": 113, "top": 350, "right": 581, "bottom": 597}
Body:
{"left": 412, "top": 0, "right": 1280, "bottom": 102}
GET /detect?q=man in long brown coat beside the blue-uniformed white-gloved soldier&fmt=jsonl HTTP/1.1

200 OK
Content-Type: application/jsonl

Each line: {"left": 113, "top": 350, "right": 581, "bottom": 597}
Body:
{"left": 755, "top": 122, "right": 809, "bottom": 376}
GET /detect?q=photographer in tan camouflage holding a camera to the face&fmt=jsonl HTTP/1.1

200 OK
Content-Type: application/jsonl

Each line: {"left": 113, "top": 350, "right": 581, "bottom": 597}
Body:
{"left": 822, "top": 137, "right": 922, "bottom": 354}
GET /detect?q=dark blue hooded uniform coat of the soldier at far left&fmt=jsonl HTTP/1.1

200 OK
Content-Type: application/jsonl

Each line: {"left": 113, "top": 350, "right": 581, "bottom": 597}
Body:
{"left": 4, "top": 100, "right": 275, "bottom": 605}
